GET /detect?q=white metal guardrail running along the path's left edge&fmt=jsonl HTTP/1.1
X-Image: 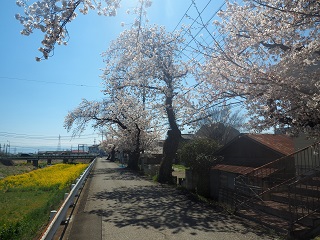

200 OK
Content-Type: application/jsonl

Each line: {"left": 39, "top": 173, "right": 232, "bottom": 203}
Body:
{"left": 40, "top": 158, "right": 96, "bottom": 240}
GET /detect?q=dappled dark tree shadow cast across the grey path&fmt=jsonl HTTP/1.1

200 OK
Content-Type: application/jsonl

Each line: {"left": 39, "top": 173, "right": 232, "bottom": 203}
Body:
{"left": 90, "top": 167, "right": 276, "bottom": 236}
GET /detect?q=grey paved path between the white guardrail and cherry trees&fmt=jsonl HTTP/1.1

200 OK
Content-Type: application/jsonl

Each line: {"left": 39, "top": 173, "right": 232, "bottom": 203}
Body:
{"left": 64, "top": 158, "right": 275, "bottom": 240}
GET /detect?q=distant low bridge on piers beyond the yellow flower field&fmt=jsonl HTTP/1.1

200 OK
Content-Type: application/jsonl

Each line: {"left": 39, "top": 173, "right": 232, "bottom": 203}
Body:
{"left": 0, "top": 154, "right": 97, "bottom": 166}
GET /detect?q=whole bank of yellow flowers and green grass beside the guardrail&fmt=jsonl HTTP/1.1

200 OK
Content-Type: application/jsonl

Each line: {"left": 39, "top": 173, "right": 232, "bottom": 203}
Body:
{"left": 0, "top": 164, "right": 87, "bottom": 240}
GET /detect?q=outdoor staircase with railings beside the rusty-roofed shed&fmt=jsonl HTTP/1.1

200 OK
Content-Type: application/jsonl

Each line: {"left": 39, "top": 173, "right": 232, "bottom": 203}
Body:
{"left": 235, "top": 142, "right": 320, "bottom": 239}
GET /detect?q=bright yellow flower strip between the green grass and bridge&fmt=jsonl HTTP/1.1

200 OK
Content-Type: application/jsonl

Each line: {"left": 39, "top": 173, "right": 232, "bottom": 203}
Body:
{"left": 0, "top": 164, "right": 88, "bottom": 191}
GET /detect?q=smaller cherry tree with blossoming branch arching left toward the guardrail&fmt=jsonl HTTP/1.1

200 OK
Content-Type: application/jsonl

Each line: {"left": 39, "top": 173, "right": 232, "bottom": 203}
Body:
{"left": 65, "top": 92, "right": 159, "bottom": 170}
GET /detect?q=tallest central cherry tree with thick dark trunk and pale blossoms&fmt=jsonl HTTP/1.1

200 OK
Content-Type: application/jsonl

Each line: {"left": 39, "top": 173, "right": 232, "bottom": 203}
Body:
{"left": 102, "top": 26, "right": 192, "bottom": 183}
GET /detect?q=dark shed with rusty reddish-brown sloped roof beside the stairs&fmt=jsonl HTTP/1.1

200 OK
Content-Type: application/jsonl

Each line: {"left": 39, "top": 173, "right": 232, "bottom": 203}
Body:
{"left": 210, "top": 134, "right": 295, "bottom": 200}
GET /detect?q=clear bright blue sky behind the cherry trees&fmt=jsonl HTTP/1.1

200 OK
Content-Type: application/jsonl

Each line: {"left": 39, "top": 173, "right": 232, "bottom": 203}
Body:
{"left": 0, "top": 0, "right": 223, "bottom": 153}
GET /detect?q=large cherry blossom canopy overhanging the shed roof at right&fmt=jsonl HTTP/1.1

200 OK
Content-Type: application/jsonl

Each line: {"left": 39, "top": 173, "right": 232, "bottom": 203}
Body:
{"left": 198, "top": 0, "right": 320, "bottom": 135}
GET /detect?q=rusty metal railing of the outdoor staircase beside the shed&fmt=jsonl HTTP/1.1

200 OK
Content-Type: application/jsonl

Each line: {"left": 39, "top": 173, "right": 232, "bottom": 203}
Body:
{"left": 234, "top": 142, "right": 320, "bottom": 224}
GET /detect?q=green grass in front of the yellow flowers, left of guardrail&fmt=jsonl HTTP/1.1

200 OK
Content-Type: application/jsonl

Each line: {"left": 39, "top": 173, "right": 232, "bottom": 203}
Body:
{"left": 0, "top": 190, "right": 65, "bottom": 240}
